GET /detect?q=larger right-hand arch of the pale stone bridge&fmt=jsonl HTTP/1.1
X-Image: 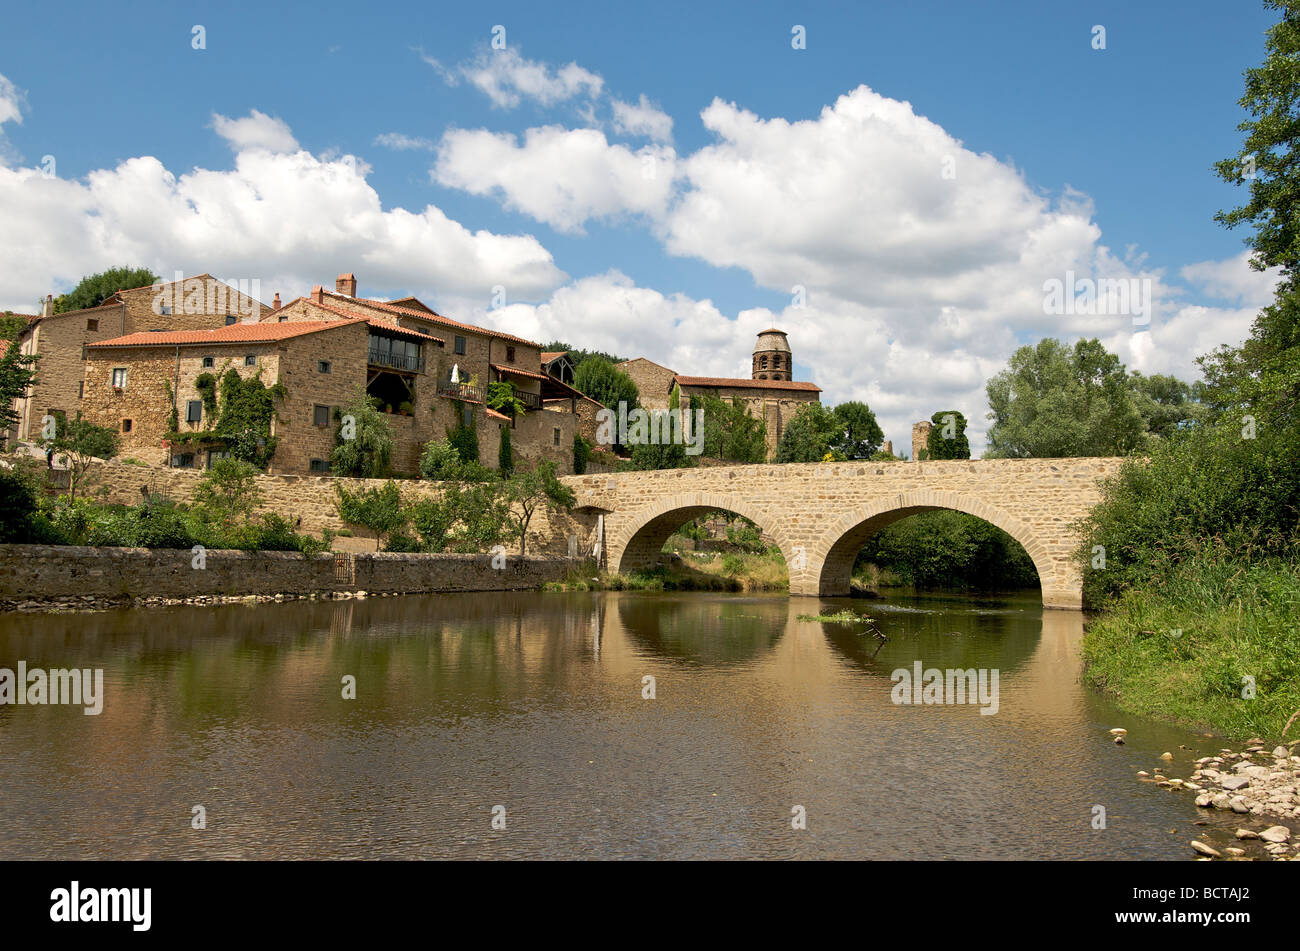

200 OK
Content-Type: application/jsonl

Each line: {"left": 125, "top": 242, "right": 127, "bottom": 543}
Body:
{"left": 811, "top": 488, "right": 1083, "bottom": 608}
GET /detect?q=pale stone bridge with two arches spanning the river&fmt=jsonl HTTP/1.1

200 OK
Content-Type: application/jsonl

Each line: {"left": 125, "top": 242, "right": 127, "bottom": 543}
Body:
{"left": 566, "top": 459, "right": 1121, "bottom": 608}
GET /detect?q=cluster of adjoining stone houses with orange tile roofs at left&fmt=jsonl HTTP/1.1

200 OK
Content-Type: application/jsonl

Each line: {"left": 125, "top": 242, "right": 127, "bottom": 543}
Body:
{"left": 11, "top": 268, "right": 599, "bottom": 474}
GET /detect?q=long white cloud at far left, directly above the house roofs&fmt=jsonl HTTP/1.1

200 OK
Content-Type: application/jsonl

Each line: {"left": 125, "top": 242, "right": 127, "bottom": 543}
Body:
{"left": 0, "top": 113, "right": 566, "bottom": 309}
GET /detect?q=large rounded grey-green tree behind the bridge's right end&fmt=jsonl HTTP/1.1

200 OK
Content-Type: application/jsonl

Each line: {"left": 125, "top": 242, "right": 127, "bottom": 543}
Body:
{"left": 985, "top": 338, "right": 1147, "bottom": 459}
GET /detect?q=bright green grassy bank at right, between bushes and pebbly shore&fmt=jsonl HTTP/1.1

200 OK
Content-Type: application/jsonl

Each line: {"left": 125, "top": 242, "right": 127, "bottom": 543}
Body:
{"left": 1083, "top": 551, "right": 1300, "bottom": 742}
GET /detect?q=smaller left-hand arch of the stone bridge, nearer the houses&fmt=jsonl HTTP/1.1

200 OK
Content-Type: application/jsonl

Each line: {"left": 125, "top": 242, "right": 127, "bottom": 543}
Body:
{"left": 606, "top": 492, "right": 793, "bottom": 572}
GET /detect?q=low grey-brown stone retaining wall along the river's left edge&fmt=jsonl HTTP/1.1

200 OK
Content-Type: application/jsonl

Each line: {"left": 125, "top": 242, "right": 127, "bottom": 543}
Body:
{"left": 0, "top": 544, "right": 572, "bottom": 608}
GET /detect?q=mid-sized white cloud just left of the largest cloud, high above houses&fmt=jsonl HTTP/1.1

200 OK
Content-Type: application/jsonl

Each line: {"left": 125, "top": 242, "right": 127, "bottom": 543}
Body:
{"left": 430, "top": 126, "right": 676, "bottom": 234}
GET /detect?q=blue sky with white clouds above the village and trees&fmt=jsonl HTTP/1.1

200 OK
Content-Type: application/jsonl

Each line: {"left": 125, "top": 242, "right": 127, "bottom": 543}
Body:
{"left": 0, "top": 0, "right": 1270, "bottom": 444}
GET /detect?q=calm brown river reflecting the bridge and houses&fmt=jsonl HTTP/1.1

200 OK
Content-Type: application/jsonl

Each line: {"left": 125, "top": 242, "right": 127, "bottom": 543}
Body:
{"left": 0, "top": 592, "right": 1231, "bottom": 859}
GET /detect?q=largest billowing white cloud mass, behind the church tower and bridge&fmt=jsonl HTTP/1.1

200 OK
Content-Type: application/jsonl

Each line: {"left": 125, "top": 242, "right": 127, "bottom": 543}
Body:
{"left": 437, "top": 87, "right": 1270, "bottom": 451}
